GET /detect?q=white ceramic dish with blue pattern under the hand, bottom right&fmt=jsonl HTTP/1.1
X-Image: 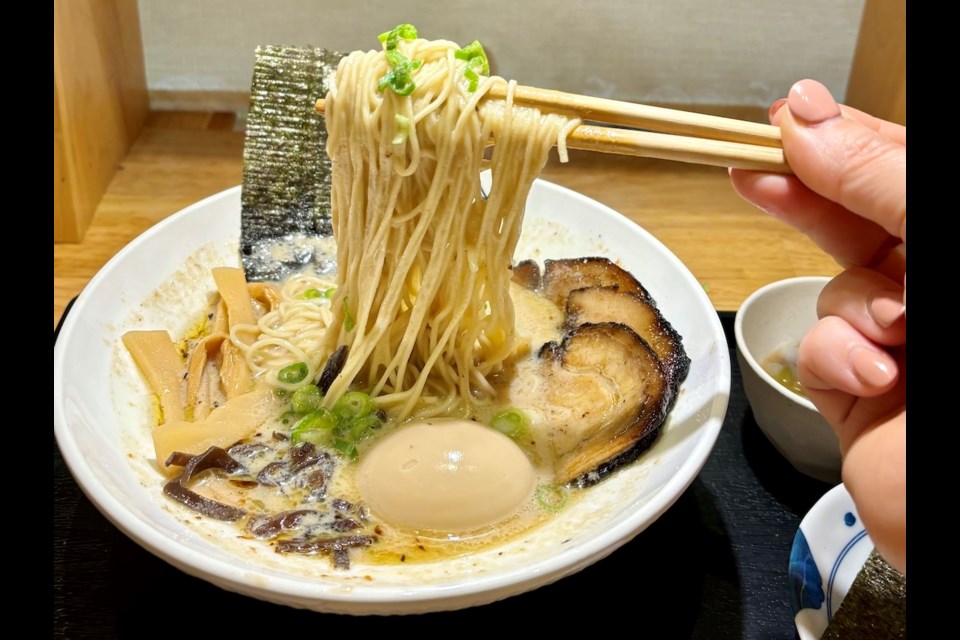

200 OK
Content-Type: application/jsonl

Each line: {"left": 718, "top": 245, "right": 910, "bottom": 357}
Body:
{"left": 789, "top": 484, "right": 873, "bottom": 640}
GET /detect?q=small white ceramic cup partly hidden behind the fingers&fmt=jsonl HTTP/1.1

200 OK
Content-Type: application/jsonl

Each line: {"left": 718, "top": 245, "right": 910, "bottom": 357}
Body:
{"left": 734, "top": 277, "right": 840, "bottom": 484}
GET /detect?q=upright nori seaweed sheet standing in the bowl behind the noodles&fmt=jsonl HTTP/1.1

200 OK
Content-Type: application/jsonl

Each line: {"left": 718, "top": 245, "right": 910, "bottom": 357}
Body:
{"left": 240, "top": 45, "right": 344, "bottom": 281}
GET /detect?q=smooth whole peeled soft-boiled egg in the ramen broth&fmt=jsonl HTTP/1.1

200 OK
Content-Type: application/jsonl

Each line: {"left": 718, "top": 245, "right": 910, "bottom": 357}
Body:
{"left": 358, "top": 418, "right": 536, "bottom": 533}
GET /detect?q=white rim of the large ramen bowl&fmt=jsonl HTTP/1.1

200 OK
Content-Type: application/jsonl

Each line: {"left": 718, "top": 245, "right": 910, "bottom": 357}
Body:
{"left": 54, "top": 179, "right": 731, "bottom": 614}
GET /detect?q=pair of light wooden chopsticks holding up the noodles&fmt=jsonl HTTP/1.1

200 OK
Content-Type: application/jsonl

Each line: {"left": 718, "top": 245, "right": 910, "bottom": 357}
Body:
{"left": 317, "top": 83, "right": 792, "bottom": 173}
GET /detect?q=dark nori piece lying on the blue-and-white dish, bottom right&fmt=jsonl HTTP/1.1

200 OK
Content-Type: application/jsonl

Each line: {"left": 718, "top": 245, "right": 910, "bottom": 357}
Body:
{"left": 821, "top": 550, "right": 907, "bottom": 640}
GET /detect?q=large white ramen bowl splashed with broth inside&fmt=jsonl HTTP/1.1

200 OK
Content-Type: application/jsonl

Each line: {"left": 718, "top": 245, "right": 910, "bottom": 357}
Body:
{"left": 53, "top": 181, "right": 730, "bottom": 614}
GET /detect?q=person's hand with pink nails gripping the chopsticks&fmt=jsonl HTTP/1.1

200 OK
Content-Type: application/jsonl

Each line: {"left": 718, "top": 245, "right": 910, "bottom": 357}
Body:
{"left": 730, "top": 80, "right": 907, "bottom": 574}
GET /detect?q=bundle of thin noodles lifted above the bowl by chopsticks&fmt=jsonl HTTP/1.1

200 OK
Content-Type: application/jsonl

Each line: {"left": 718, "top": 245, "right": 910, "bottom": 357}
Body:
{"left": 321, "top": 39, "right": 577, "bottom": 420}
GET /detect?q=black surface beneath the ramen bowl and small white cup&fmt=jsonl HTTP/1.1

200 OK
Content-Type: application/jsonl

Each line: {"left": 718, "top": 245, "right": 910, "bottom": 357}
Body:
{"left": 53, "top": 307, "right": 830, "bottom": 640}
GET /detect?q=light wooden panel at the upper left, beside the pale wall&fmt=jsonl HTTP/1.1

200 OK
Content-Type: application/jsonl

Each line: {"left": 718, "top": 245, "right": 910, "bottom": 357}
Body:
{"left": 53, "top": 0, "right": 149, "bottom": 242}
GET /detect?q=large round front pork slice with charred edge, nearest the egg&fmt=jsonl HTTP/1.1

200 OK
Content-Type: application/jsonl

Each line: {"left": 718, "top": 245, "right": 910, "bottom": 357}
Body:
{"left": 533, "top": 322, "right": 673, "bottom": 486}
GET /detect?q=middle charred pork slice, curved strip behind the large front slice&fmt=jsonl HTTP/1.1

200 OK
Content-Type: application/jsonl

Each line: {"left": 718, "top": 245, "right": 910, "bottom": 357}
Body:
{"left": 564, "top": 287, "right": 690, "bottom": 396}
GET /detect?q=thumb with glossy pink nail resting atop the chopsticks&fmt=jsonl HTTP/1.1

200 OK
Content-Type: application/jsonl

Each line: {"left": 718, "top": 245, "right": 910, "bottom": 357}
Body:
{"left": 778, "top": 80, "right": 907, "bottom": 242}
